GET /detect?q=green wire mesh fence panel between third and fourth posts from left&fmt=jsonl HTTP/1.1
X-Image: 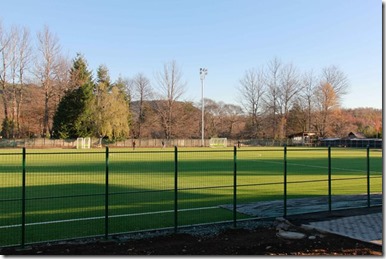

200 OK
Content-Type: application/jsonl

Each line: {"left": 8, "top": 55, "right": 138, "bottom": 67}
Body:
{"left": 178, "top": 148, "right": 234, "bottom": 228}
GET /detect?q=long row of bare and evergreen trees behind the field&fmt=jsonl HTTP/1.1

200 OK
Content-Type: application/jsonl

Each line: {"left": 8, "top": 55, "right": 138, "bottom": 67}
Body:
{"left": 0, "top": 24, "right": 382, "bottom": 140}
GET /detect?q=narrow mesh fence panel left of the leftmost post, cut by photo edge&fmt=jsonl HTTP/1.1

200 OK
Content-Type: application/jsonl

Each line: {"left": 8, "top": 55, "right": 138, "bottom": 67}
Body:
{"left": 0, "top": 152, "right": 22, "bottom": 246}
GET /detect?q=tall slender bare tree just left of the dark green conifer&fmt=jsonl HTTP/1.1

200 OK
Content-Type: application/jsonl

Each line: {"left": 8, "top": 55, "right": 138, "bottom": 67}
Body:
{"left": 34, "top": 26, "right": 61, "bottom": 136}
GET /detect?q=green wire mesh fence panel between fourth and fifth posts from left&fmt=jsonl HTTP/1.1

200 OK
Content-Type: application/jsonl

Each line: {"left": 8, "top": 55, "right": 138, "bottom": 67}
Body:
{"left": 237, "top": 147, "right": 283, "bottom": 217}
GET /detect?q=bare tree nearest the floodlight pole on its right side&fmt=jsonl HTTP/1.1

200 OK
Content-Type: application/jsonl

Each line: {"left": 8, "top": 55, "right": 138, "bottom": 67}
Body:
{"left": 238, "top": 69, "right": 265, "bottom": 137}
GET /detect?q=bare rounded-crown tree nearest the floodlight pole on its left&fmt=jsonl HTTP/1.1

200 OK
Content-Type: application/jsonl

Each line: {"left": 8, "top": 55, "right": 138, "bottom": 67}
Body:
{"left": 156, "top": 60, "right": 186, "bottom": 139}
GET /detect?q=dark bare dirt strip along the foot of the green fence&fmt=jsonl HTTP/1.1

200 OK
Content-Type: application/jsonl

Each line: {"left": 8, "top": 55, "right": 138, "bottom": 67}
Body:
{"left": 0, "top": 208, "right": 383, "bottom": 256}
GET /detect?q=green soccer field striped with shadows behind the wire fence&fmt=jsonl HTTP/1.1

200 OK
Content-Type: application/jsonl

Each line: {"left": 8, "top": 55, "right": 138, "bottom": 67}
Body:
{"left": 0, "top": 147, "right": 382, "bottom": 246}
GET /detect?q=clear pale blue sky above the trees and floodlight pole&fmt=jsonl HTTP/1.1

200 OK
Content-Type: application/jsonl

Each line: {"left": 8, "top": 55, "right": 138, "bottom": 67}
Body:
{"left": 0, "top": 0, "right": 382, "bottom": 108}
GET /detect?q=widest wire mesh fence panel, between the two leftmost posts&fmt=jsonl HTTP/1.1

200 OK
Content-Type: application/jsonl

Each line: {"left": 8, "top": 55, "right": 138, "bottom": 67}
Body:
{"left": 25, "top": 152, "right": 105, "bottom": 243}
